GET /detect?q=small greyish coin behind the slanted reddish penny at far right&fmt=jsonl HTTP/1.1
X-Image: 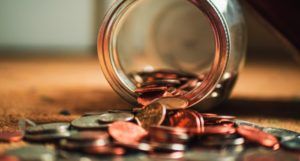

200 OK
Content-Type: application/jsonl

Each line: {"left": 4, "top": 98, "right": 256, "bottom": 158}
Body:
{"left": 262, "top": 127, "right": 300, "bottom": 140}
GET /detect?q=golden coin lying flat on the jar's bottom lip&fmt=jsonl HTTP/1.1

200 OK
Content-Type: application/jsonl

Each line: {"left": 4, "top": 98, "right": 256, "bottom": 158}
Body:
{"left": 157, "top": 97, "right": 189, "bottom": 110}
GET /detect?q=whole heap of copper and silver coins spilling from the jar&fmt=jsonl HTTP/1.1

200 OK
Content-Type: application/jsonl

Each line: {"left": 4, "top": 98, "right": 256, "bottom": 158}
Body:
{"left": 0, "top": 71, "right": 300, "bottom": 160}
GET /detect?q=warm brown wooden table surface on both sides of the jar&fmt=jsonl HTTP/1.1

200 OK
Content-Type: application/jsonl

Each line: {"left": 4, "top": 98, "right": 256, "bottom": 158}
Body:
{"left": 0, "top": 56, "right": 300, "bottom": 151}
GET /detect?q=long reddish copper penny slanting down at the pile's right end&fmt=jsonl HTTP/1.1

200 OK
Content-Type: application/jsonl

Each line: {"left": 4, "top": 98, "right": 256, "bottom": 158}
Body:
{"left": 237, "top": 125, "right": 279, "bottom": 149}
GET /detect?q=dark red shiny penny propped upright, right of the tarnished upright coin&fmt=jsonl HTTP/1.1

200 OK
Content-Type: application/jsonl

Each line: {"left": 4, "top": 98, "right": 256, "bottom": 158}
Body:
{"left": 169, "top": 110, "right": 203, "bottom": 133}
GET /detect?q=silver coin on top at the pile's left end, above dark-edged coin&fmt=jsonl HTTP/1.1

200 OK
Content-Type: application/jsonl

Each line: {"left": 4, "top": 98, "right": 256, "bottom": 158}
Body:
{"left": 25, "top": 122, "right": 70, "bottom": 134}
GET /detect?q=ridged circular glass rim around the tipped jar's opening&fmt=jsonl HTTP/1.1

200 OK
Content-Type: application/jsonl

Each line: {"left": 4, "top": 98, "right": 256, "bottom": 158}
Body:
{"left": 97, "top": 0, "right": 230, "bottom": 106}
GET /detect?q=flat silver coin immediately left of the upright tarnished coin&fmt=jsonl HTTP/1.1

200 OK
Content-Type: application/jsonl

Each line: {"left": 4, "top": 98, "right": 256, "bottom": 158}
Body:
{"left": 99, "top": 112, "right": 134, "bottom": 123}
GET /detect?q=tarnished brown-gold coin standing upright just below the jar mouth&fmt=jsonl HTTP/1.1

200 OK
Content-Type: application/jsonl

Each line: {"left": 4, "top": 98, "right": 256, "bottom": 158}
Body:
{"left": 135, "top": 102, "right": 166, "bottom": 130}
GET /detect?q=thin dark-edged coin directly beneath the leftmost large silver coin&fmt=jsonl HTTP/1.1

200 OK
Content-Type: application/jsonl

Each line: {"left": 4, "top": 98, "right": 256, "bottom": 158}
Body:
{"left": 25, "top": 132, "right": 71, "bottom": 141}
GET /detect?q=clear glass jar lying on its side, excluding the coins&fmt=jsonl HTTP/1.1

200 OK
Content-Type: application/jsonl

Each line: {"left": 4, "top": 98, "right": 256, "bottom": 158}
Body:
{"left": 98, "top": 0, "right": 246, "bottom": 110}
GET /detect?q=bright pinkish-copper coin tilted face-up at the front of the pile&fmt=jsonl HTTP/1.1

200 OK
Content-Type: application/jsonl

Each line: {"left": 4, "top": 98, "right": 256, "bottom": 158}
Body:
{"left": 108, "top": 121, "right": 148, "bottom": 144}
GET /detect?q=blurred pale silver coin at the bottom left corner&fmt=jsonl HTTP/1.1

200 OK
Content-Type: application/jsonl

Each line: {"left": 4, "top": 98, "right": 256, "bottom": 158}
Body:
{"left": 6, "top": 145, "right": 56, "bottom": 161}
